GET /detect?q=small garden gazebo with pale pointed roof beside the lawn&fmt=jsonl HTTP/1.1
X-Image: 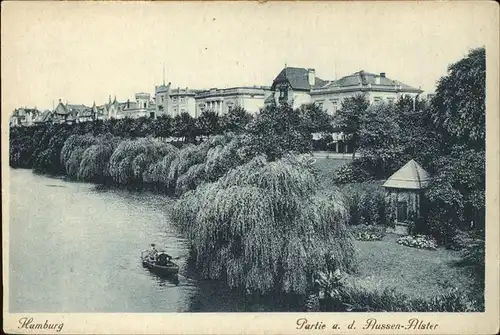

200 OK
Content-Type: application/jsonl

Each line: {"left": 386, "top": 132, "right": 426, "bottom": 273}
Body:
{"left": 383, "top": 159, "right": 430, "bottom": 233}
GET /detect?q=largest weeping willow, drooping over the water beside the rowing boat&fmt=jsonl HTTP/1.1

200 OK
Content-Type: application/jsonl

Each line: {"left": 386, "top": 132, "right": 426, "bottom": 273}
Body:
{"left": 172, "top": 156, "right": 355, "bottom": 294}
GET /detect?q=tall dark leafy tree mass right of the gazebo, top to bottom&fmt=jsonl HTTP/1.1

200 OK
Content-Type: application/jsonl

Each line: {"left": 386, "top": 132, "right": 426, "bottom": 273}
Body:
{"left": 426, "top": 48, "right": 486, "bottom": 236}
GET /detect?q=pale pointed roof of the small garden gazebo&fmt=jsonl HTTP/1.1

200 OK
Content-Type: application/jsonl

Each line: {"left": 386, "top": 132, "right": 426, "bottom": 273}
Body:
{"left": 383, "top": 159, "right": 430, "bottom": 190}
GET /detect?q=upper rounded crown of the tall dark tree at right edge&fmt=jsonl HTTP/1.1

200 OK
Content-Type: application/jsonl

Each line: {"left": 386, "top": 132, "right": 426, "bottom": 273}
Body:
{"left": 432, "top": 48, "right": 486, "bottom": 149}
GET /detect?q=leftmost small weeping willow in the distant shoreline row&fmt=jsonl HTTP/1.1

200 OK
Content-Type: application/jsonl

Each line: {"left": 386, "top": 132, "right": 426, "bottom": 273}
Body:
{"left": 60, "top": 134, "right": 97, "bottom": 179}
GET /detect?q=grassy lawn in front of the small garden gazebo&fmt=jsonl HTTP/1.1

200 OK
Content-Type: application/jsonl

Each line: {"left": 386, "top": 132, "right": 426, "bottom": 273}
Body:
{"left": 353, "top": 234, "right": 473, "bottom": 297}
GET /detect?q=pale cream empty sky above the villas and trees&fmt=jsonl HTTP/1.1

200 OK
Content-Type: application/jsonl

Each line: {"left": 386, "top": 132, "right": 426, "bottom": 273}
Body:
{"left": 1, "top": 2, "right": 498, "bottom": 113}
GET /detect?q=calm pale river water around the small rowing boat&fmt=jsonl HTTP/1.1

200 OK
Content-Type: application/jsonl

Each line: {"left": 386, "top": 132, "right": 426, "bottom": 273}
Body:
{"left": 9, "top": 169, "right": 296, "bottom": 313}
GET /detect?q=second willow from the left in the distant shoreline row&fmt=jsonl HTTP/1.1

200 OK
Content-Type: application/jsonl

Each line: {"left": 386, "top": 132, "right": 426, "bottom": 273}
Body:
{"left": 78, "top": 134, "right": 120, "bottom": 183}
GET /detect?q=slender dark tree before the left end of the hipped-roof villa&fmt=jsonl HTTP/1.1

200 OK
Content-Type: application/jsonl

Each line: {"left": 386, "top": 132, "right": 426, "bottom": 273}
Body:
{"left": 334, "top": 95, "right": 369, "bottom": 158}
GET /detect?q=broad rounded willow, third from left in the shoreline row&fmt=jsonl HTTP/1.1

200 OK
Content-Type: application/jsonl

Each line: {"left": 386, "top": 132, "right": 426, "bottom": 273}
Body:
{"left": 109, "top": 138, "right": 170, "bottom": 186}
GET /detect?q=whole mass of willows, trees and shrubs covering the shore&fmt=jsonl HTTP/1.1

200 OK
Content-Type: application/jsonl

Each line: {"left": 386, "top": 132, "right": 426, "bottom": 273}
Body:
{"left": 10, "top": 49, "right": 485, "bottom": 312}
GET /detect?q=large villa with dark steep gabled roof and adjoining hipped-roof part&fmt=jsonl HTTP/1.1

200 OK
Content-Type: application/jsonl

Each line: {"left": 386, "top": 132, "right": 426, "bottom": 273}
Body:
{"left": 266, "top": 67, "right": 423, "bottom": 115}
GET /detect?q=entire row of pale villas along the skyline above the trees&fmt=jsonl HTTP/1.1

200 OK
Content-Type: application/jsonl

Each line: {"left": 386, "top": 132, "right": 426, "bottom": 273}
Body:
{"left": 10, "top": 66, "right": 422, "bottom": 126}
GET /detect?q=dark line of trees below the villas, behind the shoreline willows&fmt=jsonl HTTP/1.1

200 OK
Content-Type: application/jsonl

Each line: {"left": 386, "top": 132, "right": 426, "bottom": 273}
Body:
{"left": 10, "top": 104, "right": 331, "bottom": 175}
